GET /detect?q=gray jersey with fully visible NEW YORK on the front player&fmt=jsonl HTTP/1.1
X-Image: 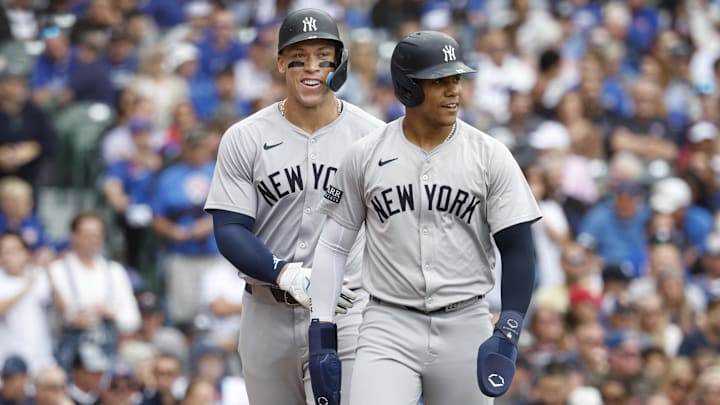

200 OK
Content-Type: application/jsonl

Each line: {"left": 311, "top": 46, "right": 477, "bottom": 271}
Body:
{"left": 320, "top": 118, "right": 540, "bottom": 311}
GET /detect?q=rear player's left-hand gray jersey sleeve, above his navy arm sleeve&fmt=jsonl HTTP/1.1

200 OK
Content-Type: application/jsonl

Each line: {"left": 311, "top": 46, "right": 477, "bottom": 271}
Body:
{"left": 205, "top": 125, "right": 257, "bottom": 218}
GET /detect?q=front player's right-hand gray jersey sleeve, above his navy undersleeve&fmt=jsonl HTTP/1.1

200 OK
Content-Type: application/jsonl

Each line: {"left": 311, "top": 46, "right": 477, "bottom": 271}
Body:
{"left": 486, "top": 142, "right": 541, "bottom": 234}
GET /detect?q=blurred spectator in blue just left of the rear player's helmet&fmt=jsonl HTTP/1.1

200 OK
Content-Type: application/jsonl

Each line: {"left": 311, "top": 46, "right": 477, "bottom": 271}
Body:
{"left": 198, "top": 10, "right": 245, "bottom": 76}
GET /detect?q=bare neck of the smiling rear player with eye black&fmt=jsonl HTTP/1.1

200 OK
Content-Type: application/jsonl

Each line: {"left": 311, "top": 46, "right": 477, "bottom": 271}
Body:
{"left": 280, "top": 94, "right": 342, "bottom": 134}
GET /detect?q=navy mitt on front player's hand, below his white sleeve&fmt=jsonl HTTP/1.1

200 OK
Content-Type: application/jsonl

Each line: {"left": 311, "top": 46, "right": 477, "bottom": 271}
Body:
{"left": 308, "top": 319, "right": 342, "bottom": 405}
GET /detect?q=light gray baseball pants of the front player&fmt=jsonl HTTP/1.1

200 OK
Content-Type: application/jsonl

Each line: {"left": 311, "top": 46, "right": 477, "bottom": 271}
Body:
{"left": 350, "top": 300, "right": 492, "bottom": 405}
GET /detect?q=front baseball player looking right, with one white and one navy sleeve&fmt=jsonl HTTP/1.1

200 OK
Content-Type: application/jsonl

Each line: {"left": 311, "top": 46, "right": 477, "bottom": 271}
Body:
{"left": 309, "top": 31, "right": 540, "bottom": 405}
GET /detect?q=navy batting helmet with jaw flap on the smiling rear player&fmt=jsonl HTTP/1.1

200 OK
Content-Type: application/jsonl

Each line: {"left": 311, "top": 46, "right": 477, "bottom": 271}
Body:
{"left": 278, "top": 8, "right": 348, "bottom": 91}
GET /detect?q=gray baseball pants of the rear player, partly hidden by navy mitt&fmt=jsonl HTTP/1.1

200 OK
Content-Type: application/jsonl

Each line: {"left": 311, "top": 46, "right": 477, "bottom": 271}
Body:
{"left": 238, "top": 287, "right": 368, "bottom": 405}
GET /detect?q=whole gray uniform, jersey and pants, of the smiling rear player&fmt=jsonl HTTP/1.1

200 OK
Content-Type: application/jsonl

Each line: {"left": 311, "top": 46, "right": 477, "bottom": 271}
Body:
{"left": 205, "top": 103, "right": 385, "bottom": 405}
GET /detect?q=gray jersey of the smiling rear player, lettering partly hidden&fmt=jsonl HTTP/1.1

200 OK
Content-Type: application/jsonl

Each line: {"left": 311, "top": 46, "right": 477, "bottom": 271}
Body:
{"left": 205, "top": 103, "right": 385, "bottom": 288}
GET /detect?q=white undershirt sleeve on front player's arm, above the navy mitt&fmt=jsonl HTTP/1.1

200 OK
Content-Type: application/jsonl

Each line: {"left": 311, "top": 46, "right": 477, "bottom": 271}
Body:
{"left": 310, "top": 218, "right": 358, "bottom": 322}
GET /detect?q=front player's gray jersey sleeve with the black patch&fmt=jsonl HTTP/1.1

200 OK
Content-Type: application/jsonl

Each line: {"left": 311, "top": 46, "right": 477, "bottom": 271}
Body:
{"left": 319, "top": 142, "right": 365, "bottom": 230}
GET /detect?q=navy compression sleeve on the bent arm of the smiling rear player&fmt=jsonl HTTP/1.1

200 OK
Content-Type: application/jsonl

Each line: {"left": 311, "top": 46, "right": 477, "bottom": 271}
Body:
{"left": 210, "top": 210, "right": 286, "bottom": 284}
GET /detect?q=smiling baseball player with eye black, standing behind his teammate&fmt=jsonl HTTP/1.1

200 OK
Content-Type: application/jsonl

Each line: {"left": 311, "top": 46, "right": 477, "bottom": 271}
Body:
{"left": 205, "top": 9, "right": 384, "bottom": 405}
